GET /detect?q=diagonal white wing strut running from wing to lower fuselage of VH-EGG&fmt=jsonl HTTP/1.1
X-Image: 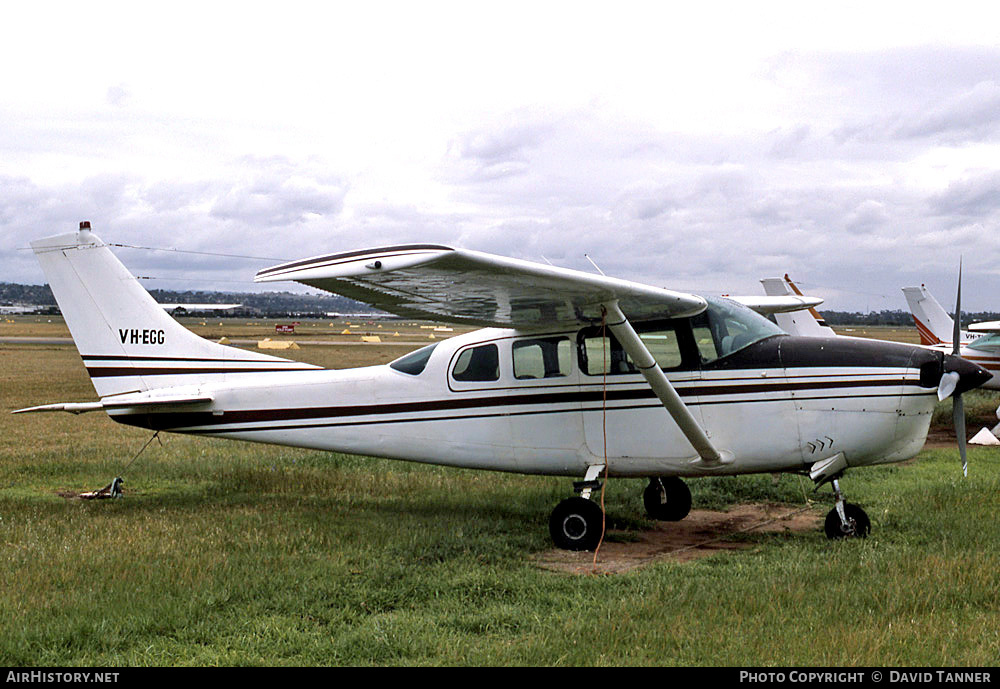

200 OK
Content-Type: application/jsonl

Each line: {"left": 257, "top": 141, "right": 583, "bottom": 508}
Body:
{"left": 604, "top": 301, "right": 733, "bottom": 468}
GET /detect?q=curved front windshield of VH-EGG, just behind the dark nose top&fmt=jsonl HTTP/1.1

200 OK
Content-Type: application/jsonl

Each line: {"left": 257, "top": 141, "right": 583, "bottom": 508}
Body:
{"left": 691, "top": 297, "right": 785, "bottom": 363}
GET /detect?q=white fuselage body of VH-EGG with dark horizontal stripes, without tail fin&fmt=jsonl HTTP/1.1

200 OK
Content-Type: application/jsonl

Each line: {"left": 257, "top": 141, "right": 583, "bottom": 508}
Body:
{"left": 110, "top": 329, "right": 937, "bottom": 476}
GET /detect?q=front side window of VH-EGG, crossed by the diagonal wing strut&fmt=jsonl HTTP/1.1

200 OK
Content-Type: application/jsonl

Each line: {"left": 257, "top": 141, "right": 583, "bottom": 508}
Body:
{"left": 579, "top": 321, "right": 684, "bottom": 376}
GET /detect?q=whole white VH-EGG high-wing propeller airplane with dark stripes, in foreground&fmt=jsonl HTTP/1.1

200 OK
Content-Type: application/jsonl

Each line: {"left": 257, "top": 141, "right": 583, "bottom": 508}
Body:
{"left": 20, "top": 223, "right": 989, "bottom": 550}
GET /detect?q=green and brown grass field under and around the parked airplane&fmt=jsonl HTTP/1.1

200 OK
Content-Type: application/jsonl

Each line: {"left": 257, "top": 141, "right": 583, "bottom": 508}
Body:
{"left": 0, "top": 321, "right": 1000, "bottom": 667}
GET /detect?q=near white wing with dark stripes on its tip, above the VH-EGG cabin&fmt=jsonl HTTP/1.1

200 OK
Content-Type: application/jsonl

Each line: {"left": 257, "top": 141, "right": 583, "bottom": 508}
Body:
{"left": 254, "top": 244, "right": 706, "bottom": 328}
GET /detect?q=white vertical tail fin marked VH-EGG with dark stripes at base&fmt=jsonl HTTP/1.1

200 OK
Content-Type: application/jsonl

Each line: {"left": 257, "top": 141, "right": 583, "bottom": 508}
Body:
{"left": 31, "top": 223, "right": 315, "bottom": 397}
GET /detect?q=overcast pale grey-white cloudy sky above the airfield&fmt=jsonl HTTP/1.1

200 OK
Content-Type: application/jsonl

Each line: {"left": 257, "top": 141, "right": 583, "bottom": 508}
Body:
{"left": 0, "top": 0, "right": 1000, "bottom": 311}
